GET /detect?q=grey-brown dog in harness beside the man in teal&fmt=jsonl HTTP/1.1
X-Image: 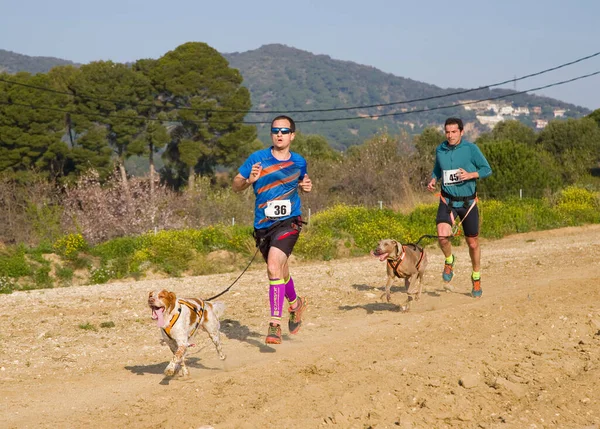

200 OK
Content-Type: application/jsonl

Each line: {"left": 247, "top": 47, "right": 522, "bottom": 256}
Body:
{"left": 371, "top": 238, "right": 427, "bottom": 311}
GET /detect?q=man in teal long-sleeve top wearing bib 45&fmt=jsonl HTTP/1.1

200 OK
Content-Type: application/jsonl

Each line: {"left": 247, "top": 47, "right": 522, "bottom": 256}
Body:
{"left": 427, "top": 118, "right": 492, "bottom": 298}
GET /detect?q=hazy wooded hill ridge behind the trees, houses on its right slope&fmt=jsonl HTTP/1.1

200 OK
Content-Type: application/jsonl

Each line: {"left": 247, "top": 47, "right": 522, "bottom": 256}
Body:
{"left": 0, "top": 44, "right": 590, "bottom": 149}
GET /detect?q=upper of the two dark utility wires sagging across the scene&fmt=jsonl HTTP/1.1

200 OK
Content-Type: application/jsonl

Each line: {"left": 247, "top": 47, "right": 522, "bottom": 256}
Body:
{"left": 0, "top": 52, "right": 600, "bottom": 115}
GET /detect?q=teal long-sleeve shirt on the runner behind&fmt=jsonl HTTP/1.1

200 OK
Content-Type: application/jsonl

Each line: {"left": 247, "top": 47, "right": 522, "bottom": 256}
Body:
{"left": 431, "top": 140, "right": 492, "bottom": 204}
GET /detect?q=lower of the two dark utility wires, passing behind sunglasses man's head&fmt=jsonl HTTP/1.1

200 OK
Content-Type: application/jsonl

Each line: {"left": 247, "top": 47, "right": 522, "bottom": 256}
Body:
{"left": 0, "top": 70, "right": 600, "bottom": 125}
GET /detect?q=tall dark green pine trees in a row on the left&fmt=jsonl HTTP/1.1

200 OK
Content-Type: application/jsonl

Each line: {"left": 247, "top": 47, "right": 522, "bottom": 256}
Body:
{"left": 0, "top": 43, "right": 261, "bottom": 191}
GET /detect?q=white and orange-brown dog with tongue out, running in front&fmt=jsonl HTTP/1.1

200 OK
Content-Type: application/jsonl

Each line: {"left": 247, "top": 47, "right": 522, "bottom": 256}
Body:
{"left": 148, "top": 289, "right": 225, "bottom": 376}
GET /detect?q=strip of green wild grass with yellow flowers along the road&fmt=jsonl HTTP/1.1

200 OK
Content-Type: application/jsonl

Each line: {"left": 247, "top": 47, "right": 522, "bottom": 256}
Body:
{"left": 0, "top": 187, "right": 600, "bottom": 290}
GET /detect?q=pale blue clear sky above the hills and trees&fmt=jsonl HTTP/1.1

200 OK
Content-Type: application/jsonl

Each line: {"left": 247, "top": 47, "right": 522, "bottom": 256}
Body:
{"left": 0, "top": 0, "right": 600, "bottom": 109}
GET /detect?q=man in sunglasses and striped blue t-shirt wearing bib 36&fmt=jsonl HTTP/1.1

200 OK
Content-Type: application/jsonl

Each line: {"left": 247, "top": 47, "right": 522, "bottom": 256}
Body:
{"left": 232, "top": 116, "right": 312, "bottom": 344}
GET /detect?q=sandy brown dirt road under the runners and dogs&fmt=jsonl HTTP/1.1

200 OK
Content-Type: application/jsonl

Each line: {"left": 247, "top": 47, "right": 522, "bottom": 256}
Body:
{"left": 0, "top": 225, "right": 600, "bottom": 429}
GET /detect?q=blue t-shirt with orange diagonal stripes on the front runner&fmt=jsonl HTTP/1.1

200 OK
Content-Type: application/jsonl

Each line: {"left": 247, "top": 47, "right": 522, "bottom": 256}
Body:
{"left": 239, "top": 147, "right": 306, "bottom": 229}
